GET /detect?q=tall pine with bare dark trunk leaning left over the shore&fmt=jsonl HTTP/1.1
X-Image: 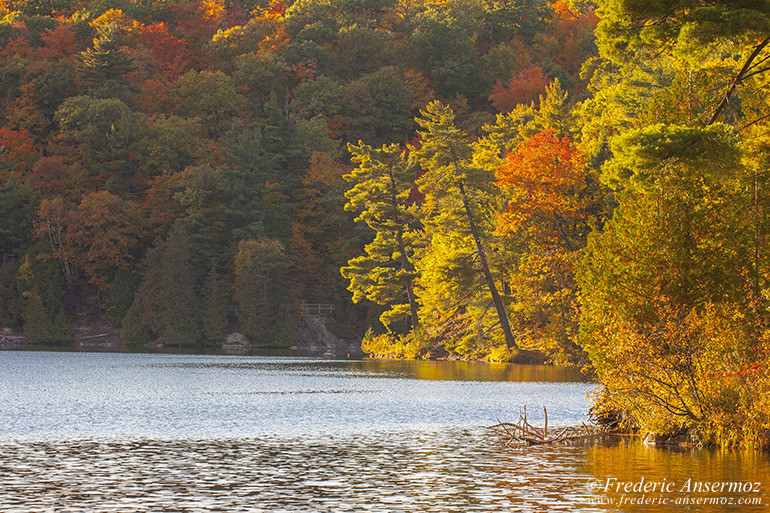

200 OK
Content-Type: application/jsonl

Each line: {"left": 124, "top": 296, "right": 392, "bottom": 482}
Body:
{"left": 415, "top": 102, "right": 518, "bottom": 349}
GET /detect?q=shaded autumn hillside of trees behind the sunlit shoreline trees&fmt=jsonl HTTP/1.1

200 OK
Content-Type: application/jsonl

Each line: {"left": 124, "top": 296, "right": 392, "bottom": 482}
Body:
{"left": 0, "top": 0, "right": 595, "bottom": 347}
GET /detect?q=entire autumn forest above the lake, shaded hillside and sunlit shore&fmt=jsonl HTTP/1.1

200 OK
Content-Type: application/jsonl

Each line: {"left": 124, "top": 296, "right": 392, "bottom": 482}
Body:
{"left": 0, "top": 0, "right": 770, "bottom": 446}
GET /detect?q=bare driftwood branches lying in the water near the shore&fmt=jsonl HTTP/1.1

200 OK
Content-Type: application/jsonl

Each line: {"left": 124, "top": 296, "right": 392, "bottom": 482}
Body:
{"left": 488, "top": 405, "right": 610, "bottom": 445}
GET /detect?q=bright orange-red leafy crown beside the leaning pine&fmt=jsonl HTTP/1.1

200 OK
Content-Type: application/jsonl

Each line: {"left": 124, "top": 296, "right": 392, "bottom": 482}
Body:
{"left": 496, "top": 131, "right": 590, "bottom": 246}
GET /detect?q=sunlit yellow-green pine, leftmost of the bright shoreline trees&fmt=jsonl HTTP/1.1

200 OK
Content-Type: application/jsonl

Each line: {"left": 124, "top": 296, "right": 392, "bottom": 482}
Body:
{"left": 341, "top": 142, "right": 420, "bottom": 329}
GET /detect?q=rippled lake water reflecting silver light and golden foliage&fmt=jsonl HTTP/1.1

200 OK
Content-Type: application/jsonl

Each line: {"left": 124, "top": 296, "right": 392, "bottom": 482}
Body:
{"left": 0, "top": 352, "right": 770, "bottom": 512}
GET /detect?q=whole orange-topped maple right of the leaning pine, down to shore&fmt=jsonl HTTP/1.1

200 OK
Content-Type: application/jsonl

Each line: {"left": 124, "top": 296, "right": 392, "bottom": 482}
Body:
{"left": 496, "top": 132, "right": 603, "bottom": 364}
